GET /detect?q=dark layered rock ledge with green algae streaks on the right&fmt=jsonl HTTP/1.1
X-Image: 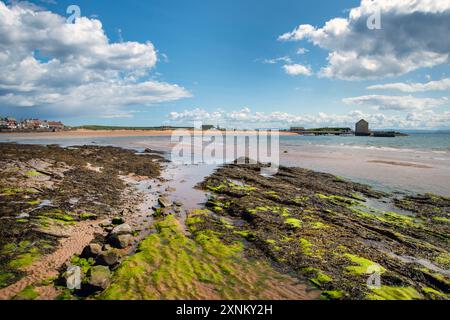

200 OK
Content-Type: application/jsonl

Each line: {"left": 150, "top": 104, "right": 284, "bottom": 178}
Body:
{"left": 200, "top": 164, "right": 450, "bottom": 299}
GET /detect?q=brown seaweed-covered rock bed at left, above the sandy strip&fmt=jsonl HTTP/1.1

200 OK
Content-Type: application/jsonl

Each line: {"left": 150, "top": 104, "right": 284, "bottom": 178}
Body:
{"left": 0, "top": 143, "right": 163, "bottom": 294}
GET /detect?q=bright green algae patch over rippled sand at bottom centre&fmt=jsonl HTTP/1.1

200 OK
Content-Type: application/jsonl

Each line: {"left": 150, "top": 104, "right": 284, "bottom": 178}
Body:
{"left": 99, "top": 214, "right": 318, "bottom": 300}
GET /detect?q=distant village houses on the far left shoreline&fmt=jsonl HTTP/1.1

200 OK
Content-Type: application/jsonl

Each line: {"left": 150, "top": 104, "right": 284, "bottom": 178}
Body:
{"left": 0, "top": 117, "right": 68, "bottom": 132}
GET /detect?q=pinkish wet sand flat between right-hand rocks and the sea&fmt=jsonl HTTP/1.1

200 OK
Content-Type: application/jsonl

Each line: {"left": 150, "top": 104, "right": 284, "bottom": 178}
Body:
{"left": 281, "top": 146, "right": 450, "bottom": 196}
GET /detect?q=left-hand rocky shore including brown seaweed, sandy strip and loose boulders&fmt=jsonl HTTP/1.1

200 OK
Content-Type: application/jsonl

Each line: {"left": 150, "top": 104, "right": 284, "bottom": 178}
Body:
{"left": 0, "top": 144, "right": 166, "bottom": 299}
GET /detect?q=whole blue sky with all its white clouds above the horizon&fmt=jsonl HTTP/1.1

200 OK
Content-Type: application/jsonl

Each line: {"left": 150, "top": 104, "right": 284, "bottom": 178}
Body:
{"left": 0, "top": 0, "right": 450, "bottom": 129}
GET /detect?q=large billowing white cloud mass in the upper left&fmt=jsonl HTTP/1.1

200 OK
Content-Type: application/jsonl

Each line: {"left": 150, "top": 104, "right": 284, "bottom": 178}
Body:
{"left": 0, "top": 1, "right": 190, "bottom": 116}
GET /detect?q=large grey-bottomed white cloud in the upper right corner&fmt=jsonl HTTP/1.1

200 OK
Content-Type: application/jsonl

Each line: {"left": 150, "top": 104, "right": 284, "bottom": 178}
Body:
{"left": 279, "top": 0, "right": 450, "bottom": 80}
